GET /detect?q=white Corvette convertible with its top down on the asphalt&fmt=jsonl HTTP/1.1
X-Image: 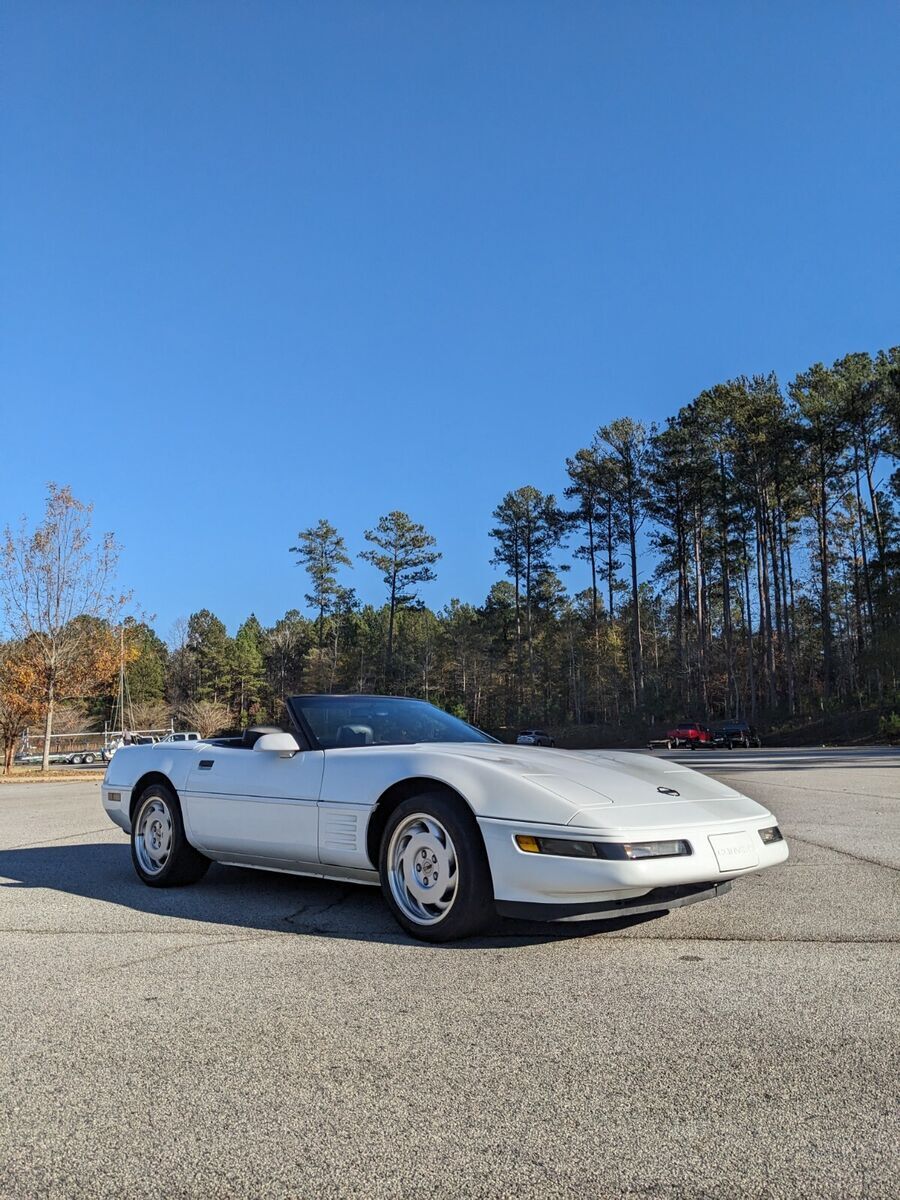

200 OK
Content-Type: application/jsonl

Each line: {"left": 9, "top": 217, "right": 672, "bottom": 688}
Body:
{"left": 102, "top": 695, "right": 787, "bottom": 941}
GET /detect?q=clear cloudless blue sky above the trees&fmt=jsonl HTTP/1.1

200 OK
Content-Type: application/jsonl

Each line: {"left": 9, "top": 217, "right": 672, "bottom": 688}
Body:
{"left": 0, "top": 0, "right": 900, "bottom": 635}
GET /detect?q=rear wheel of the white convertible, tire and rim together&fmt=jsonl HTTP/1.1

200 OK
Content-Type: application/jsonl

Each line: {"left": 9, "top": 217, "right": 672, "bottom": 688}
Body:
{"left": 131, "top": 784, "right": 209, "bottom": 888}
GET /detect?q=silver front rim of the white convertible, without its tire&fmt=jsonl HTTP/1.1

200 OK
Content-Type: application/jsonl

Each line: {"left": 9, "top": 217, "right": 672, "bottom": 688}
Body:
{"left": 388, "top": 812, "right": 460, "bottom": 925}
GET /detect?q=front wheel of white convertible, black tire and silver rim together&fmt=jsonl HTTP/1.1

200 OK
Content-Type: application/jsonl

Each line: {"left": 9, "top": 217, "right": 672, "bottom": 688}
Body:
{"left": 379, "top": 792, "right": 494, "bottom": 942}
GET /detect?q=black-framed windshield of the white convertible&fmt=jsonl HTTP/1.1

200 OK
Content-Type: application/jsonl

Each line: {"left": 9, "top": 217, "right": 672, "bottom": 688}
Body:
{"left": 290, "top": 696, "right": 494, "bottom": 750}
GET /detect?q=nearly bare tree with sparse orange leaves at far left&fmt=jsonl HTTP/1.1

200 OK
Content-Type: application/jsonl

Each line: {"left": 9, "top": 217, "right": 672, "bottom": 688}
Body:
{"left": 0, "top": 484, "right": 127, "bottom": 770}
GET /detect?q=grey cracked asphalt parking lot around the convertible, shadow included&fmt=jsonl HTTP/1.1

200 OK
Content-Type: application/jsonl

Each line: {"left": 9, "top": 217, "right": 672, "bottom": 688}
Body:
{"left": 0, "top": 750, "right": 900, "bottom": 1200}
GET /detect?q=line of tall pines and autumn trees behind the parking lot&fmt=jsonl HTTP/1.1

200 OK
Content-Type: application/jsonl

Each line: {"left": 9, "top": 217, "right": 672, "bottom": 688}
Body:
{"left": 0, "top": 347, "right": 900, "bottom": 768}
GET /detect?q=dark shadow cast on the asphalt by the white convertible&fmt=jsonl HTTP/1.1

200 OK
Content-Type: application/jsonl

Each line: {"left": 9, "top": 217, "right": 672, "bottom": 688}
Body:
{"left": 0, "top": 842, "right": 664, "bottom": 949}
